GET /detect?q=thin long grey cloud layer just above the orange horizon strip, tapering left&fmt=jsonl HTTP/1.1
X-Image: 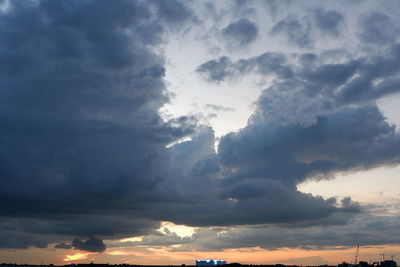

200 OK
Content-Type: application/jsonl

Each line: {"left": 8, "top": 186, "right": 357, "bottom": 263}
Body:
{"left": 126, "top": 214, "right": 400, "bottom": 251}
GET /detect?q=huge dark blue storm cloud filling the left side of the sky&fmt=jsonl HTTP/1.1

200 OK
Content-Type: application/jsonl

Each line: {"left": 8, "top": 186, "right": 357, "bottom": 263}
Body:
{"left": 0, "top": 0, "right": 192, "bottom": 251}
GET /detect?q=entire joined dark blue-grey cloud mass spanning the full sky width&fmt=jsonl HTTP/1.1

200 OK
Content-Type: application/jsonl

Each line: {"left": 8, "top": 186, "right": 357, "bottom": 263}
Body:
{"left": 0, "top": 0, "right": 400, "bottom": 252}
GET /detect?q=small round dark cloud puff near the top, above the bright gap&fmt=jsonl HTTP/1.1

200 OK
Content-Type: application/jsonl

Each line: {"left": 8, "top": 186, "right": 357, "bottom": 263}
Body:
{"left": 222, "top": 19, "right": 258, "bottom": 46}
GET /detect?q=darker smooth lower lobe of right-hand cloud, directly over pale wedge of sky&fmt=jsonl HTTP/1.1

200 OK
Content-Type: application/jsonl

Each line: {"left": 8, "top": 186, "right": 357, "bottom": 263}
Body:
{"left": 222, "top": 104, "right": 400, "bottom": 186}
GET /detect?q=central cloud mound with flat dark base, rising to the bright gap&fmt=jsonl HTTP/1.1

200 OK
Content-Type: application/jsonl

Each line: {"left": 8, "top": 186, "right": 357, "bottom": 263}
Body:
{"left": 140, "top": 127, "right": 360, "bottom": 226}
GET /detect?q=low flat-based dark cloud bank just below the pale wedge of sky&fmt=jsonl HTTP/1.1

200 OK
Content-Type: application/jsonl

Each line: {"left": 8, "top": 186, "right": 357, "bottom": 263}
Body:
{"left": 147, "top": 178, "right": 360, "bottom": 226}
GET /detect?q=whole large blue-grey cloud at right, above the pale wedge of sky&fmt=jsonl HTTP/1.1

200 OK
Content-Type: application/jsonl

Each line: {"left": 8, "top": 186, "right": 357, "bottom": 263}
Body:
{"left": 199, "top": 45, "right": 400, "bottom": 197}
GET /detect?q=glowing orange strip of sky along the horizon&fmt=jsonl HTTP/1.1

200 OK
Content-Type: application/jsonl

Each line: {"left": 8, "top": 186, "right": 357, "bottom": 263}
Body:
{"left": 0, "top": 245, "right": 400, "bottom": 265}
